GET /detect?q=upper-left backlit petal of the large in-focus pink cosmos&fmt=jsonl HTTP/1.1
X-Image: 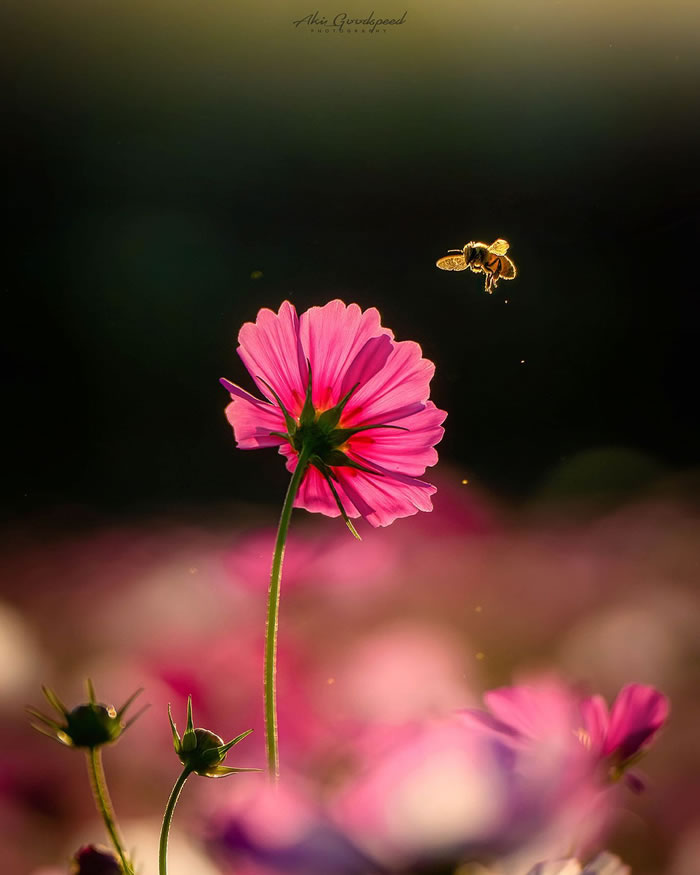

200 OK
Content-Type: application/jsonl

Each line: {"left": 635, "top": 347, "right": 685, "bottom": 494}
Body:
{"left": 238, "top": 301, "right": 308, "bottom": 416}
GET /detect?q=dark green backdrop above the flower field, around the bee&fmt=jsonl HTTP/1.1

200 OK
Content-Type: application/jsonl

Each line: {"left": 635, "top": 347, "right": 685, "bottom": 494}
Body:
{"left": 2, "top": 0, "right": 700, "bottom": 512}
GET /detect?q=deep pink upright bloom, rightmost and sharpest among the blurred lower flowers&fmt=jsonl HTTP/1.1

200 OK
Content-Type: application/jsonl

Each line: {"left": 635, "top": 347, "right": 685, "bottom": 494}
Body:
{"left": 581, "top": 684, "right": 669, "bottom": 764}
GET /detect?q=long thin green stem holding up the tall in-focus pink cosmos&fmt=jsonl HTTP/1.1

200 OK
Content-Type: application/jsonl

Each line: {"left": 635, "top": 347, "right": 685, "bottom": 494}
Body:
{"left": 264, "top": 446, "right": 311, "bottom": 782}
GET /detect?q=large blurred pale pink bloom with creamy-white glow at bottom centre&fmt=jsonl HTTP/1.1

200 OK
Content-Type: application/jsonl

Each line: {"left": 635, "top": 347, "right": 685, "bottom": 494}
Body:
{"left": 332, "top": 718, "right": 515, "bottom": 871}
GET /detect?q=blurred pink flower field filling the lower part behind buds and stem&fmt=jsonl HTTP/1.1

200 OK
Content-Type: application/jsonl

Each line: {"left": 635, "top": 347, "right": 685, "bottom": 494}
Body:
{"left": 0, "top": 476, "right": 700, "bottom": 875}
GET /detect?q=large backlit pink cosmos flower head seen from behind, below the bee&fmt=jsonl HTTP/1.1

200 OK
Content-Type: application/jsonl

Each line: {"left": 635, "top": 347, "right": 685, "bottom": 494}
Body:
{"left": 221, "top": 300, "right": 447, "bottom": 527}
